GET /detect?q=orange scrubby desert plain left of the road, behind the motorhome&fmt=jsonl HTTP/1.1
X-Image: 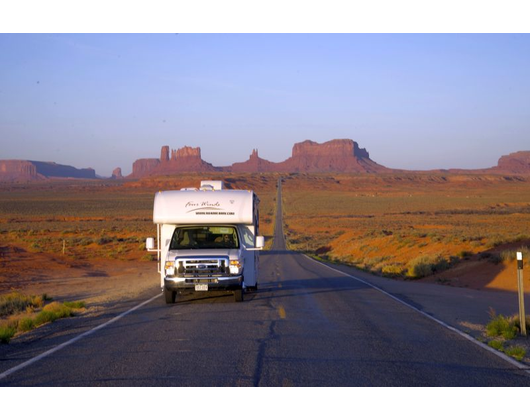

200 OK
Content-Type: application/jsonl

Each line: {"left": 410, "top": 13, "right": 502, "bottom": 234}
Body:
{"left": 0, "top": 173, "right": 277, "bottom": 291}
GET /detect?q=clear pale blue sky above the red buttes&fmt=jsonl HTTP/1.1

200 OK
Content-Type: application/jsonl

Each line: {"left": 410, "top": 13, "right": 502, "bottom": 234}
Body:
{"left": 0, "top": 34, "right": 530, "bottom": 176}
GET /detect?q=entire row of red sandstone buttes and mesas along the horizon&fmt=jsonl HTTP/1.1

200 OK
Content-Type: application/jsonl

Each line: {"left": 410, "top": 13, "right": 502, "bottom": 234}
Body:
{"left": 6, "top": 139, "right": 530, "bottom": 182}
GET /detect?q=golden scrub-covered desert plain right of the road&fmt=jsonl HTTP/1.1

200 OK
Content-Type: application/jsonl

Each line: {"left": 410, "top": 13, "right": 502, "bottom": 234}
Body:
{"left": 283, "top": 174, "right": 530, "bottom": 278}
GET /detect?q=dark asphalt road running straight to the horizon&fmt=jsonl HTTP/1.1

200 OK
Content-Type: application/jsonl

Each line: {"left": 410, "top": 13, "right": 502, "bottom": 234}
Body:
{"left": 0, "top": 180, "right": 530, "bottom": 387}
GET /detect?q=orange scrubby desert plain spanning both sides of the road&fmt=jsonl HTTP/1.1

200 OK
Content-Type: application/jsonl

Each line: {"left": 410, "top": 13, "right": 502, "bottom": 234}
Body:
{"left": 0, "top": 173, "right": 530, "bottom": 298}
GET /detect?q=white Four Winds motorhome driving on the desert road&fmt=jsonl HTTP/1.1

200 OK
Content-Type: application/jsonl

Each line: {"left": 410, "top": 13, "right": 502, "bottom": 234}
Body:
{"left": 147, "top": 181, "right": 265, "bottom": 304}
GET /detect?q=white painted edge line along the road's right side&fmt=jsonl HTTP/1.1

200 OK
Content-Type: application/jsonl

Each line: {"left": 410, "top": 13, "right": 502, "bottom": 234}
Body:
{"left": 302, "top": 254, "right": 530, "bottom": 375}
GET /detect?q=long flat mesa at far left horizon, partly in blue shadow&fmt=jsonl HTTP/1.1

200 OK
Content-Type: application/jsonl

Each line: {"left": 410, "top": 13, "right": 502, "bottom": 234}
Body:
{"left": 0, "top": 160, "right": 96, "bottom": 181}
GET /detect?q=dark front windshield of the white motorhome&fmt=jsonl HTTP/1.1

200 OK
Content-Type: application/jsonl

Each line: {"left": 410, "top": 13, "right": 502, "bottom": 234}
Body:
{"left": 170, "top": 226, "right": 239, "bottom": 251}
